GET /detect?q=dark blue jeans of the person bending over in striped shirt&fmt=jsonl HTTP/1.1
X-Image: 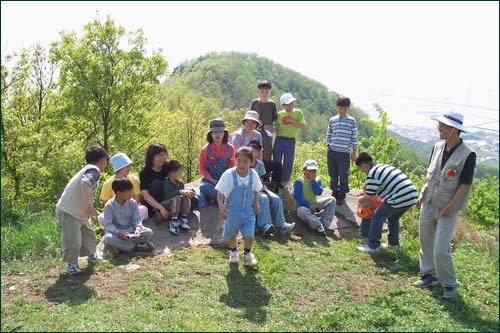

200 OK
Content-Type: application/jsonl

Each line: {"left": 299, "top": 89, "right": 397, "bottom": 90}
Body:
{"left": 368, "top": 202, "right": 411, "bottom": 249}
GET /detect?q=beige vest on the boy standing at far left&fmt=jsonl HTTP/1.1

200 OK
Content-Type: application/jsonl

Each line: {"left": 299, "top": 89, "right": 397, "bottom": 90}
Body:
{"left": 56, "top": 164, "right": 99, "bottom": 220}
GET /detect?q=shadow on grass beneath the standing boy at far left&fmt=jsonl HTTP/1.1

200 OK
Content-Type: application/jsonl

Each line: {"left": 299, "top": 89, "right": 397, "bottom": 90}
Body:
{"left": 44, "top": 265, "right": 96, "bottom": 306}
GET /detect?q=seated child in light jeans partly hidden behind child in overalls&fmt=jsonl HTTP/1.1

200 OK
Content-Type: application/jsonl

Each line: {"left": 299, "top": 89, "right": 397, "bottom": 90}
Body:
{"left": 248, "top": 141, "right": 295, "bottom": 236}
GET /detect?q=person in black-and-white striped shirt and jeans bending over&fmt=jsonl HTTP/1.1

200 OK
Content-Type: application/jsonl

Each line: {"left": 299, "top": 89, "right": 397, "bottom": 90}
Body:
{"left": 356, "top": 153, "right": 418, "bottom": 253}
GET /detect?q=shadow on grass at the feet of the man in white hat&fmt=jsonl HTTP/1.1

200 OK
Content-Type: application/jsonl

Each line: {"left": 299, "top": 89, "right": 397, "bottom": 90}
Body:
{"left": 432, "top": 288, "right": 499, "bottom": 332}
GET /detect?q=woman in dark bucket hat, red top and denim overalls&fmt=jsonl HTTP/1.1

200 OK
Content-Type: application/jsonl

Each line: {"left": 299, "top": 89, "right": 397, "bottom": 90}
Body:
{"left": 199, "top": 118, "right": 234, "bottom": 204}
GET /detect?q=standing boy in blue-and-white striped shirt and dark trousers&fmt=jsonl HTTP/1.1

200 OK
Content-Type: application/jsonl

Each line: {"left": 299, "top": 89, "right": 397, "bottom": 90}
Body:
{"left": 326, "top": 96, "right": 358, "bottom": 205}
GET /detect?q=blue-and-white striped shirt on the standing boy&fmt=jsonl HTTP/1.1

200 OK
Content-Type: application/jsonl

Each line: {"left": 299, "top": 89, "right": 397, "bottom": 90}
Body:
{"left": 326, "top": 114, "right": 358, "bottom": 153}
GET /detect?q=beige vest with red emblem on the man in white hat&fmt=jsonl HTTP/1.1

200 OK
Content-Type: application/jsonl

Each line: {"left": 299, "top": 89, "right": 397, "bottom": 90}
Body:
{"left": 422, "top": 141, "right": 472, "bottom": 210}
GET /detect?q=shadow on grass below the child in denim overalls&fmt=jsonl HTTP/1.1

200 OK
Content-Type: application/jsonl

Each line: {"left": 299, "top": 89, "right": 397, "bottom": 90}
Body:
{"left": 219, "top": 264, "right": 271, "bottom": 323}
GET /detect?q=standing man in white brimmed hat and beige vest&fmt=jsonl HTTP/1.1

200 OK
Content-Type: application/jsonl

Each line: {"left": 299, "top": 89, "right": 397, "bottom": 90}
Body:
{"left": 414, "top": 112, "right": 476, "bottom": 298}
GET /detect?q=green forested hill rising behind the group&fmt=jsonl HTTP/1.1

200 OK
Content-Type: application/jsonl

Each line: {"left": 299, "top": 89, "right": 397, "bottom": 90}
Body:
{"left": 169, "top": 52, "right": 369, "bottom": 141}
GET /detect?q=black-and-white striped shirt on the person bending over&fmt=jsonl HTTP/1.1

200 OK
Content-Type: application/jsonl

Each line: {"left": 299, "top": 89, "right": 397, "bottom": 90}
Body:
{"left": 365, "top": 164, "right": 418, "bottom": 208}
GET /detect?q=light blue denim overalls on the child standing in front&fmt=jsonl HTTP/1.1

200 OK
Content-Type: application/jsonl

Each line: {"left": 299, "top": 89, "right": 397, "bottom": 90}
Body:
{"left": 222, "top": 168, "right": 255, "bottom": 238}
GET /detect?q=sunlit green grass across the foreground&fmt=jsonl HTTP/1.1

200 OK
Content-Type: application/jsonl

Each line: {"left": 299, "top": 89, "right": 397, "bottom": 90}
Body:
{"left": 1, "top": 213, "right": 499, "bottom": 331}
